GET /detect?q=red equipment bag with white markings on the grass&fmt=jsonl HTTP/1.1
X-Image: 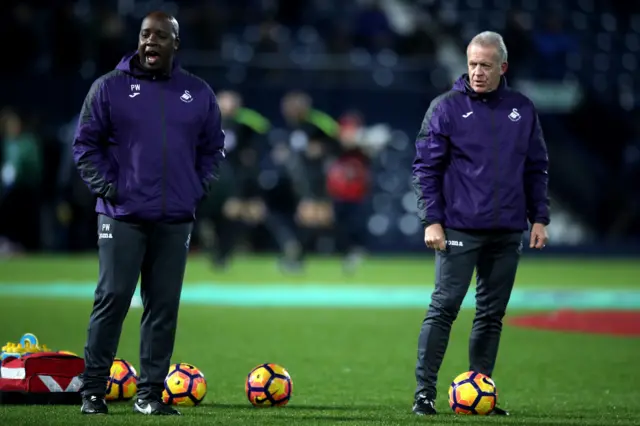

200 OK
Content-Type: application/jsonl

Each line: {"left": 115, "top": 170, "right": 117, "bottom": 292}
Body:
{"left": 0, "top": 352, "right": 84, "bottom": 404}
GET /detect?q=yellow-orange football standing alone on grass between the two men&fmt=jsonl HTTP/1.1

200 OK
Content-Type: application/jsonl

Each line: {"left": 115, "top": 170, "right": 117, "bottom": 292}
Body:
{"left": 244, "top": 364, "right": 293, "bottom": 407}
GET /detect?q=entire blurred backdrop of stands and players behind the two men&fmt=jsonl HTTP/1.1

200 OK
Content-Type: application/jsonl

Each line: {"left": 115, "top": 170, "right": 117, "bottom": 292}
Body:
{"left": 0, "top": 0, "right": 640, "bottom": 262}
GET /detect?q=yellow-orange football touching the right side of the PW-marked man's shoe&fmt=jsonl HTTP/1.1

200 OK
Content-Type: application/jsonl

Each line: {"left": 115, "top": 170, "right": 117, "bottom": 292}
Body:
{"left": 162, "top": 363, "right": 207, "bottom": 407}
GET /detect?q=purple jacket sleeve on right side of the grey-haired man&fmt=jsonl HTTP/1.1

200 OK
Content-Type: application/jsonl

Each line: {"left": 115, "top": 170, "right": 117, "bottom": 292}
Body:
{"left": 524, "top": 110, "right": 550, "bottom": 225}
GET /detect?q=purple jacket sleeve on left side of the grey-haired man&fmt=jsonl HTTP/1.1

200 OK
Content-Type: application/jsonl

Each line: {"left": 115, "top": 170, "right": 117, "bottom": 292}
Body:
{"left": 412, "top": 97, "right": 449, "bottom": 226}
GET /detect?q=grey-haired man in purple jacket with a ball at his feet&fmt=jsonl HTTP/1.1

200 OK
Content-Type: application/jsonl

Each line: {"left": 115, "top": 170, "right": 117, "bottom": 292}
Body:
{"left": 413, "top": 32, "right": 549, "bottom": 415}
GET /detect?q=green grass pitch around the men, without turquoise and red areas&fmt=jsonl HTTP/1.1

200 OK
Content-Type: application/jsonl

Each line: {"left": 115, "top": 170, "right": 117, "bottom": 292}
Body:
{"left": 0, "top": 255, "right": 640, "bottom": 426}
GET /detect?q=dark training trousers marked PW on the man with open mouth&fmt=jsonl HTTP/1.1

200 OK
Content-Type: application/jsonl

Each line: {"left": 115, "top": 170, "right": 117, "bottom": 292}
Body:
{"left": 81, "top": 215, "right": 193, "bottom": 399}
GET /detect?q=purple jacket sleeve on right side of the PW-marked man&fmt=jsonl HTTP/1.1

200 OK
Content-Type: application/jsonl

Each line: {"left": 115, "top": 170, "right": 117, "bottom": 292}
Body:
{"left": 196, "top": 89, "right": 225, "bottom": 194}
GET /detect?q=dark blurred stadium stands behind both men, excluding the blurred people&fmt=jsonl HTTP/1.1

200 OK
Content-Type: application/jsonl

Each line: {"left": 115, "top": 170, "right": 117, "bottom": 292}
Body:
{"left": 0, "top": 0, "right": 640, "bottom": 255}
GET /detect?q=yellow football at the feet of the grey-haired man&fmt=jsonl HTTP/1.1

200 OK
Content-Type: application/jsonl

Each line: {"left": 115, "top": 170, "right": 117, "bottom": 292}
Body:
{"left": 449, "top": 371, "right": 498, "bottom": 415}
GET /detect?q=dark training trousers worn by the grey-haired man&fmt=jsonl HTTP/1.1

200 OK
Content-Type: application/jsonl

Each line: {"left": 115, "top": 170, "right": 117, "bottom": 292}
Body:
{"left": 415, "top": 229, "right": 522, "bottom": 399}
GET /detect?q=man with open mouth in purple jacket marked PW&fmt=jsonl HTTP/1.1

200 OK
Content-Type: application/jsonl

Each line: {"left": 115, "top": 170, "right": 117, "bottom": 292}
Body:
{"left": 73, "top": 12, "right": 224, "bottom": 415}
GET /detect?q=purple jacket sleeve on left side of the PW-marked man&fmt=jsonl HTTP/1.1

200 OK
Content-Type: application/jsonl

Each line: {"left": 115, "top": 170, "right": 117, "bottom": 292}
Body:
{"left": 72, "top": 77, "right": 117, "bottom": 200}
